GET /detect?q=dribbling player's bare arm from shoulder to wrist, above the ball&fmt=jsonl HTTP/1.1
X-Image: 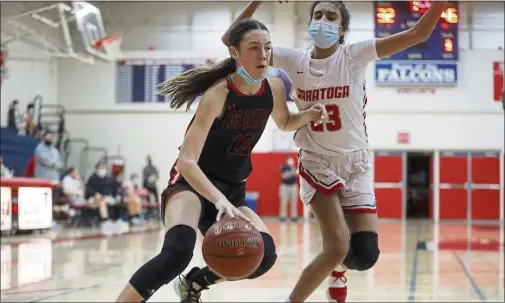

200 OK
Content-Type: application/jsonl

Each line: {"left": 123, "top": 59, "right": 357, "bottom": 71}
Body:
{"left": 177, "top": 81, "right": 228, "bottom": 203}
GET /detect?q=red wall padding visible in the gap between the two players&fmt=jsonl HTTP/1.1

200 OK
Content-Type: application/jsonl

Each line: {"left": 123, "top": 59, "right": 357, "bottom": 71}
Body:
{"left": 247, "top": 152, "right": 303, "bottom": 217}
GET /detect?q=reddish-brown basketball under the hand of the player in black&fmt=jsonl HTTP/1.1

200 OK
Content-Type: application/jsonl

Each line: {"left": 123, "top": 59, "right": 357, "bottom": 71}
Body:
{"left": 202, "top": 215, "right": 264, "bottom": 280}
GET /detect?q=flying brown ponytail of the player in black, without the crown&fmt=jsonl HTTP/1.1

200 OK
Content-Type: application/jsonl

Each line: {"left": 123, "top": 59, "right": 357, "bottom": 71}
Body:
{"left": 158, "top": 57, "right": 237, "bottom": 110}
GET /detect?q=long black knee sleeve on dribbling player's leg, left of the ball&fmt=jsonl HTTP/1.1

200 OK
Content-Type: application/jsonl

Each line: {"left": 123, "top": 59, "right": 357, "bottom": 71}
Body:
{"left": 130, "top": 225, "right": 196, "bottom": 300}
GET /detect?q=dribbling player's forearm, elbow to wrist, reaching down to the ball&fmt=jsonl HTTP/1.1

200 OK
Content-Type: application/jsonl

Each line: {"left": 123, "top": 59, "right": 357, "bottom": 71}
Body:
{"left": 177, "top": 158, "right": 225, "bottom": 203}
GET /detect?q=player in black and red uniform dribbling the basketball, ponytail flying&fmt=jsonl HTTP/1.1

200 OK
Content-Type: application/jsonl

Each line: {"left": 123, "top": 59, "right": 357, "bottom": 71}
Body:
{"left": 117, "top": 20, "right": 326, "bottom": 302}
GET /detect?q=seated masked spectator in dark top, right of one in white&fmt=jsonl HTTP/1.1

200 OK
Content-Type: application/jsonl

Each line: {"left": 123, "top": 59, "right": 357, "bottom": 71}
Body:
{"left": 86, "top": 162, "right": 128, "bottom": 234}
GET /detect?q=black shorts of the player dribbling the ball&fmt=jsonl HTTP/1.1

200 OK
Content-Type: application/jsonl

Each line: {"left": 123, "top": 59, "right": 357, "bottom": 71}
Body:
{"left": 161, "top": 178, "right": 247, "bottom": 235}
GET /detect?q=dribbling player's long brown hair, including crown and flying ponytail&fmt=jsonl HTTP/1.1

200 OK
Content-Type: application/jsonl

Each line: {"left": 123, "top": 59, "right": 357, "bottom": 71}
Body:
{"left": 158, "top": 19, "right": 268, "bottom": 110}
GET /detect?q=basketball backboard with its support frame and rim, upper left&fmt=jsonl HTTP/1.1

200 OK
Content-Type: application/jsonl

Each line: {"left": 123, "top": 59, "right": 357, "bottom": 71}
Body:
{"left": 1, "top": 1, "right": 115, "bottom": 64}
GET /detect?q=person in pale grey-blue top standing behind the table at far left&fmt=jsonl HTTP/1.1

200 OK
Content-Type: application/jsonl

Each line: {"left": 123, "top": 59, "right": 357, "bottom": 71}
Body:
{"left": 35, "top": 132, "right": 63, "bottom": 184}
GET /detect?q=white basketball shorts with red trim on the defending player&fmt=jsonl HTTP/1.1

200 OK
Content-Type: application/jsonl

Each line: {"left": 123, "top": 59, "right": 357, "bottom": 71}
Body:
{"left": 298, "top": 149, "right": 376, "bottom": 213}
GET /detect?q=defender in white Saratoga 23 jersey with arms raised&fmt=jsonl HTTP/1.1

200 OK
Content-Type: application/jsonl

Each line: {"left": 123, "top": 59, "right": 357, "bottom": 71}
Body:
{"left": 223, "top": 1, "right": 447, "bottom": 302}
